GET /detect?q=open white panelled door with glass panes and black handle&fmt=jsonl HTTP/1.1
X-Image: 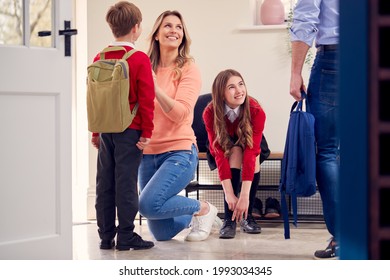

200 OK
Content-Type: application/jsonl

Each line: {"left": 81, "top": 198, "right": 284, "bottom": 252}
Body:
{"left": 0, "top": 0, "right": 74, "bottom": 260}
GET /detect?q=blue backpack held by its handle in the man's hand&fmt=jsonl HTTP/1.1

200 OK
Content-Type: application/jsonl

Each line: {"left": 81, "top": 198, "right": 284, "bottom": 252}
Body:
{"left": 279, "top": 92, "right": 317, "bottom": 239}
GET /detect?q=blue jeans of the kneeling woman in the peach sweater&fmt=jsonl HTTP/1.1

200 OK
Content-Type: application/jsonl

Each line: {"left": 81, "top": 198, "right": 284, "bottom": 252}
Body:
{"left": 138, "top": 145, "right": 200, "bottom": 241}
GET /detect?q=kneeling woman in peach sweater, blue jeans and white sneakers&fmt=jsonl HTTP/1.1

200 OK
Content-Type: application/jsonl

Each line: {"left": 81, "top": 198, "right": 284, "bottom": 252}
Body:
{"left": 139, "top": 11, "right": 217, "bottom": 241}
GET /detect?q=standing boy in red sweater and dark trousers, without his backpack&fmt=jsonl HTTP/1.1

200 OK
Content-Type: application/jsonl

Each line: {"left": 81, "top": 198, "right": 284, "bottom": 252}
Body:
{"left": 91, "top": 1, "right": 155, "bottom": 250}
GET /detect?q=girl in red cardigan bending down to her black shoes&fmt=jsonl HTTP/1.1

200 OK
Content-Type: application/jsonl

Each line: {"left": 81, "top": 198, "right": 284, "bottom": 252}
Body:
{"left": 203, "top": 69, "right": 265, "bottom": 239}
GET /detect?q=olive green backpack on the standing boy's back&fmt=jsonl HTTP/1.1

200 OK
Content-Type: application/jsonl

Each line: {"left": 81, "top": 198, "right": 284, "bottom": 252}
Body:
{"left": 87, "top": 47, "right": 138, "bottom": 133}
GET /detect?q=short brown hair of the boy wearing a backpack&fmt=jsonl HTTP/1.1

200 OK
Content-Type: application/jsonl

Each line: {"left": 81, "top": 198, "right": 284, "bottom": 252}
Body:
{"left": 106, "top": 1, "right": 142, "bottom": 38}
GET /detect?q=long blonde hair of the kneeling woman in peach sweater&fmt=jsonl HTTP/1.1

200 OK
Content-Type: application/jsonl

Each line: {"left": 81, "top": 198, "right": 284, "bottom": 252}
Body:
{"left": 148, "top": 10, "right": 193, "bottom": 79}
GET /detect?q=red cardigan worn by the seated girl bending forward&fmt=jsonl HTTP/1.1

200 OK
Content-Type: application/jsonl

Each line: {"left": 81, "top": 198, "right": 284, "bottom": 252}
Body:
{"left": 203, "top": 97, "right": 266, "bottom": 181}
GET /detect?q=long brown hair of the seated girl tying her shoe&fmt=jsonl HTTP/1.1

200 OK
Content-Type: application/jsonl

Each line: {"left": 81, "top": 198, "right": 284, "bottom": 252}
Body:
{"left": 211, "top": 69, "right": 253, "bottom": 157}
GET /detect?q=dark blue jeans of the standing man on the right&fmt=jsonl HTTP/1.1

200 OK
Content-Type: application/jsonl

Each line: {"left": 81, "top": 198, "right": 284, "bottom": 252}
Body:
{"left": 307, "top": 46, "right": 340, "bottom": 236}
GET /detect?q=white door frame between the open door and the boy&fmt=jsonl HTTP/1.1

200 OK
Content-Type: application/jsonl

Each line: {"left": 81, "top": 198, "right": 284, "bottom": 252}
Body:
{"left": 72, "top": 0, "right": 98, "bottom": 221}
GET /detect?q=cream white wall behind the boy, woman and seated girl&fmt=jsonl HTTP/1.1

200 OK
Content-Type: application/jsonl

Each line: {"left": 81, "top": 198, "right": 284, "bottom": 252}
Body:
{"left": 88, "top": 0, "right": 310, "bottom": 152}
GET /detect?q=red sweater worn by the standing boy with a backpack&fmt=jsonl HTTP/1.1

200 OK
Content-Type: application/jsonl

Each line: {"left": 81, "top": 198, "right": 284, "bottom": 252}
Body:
{"left": 93, "top": 46, "right": 155, "bottom": 138}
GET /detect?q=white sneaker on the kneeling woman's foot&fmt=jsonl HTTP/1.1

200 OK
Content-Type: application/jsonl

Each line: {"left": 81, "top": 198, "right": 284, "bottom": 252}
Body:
{"left": 185, "top": 202, "right": 218, "bottom": 241}
